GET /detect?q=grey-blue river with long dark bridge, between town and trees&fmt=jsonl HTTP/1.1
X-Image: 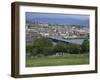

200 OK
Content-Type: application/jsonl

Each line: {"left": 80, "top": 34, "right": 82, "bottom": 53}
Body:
{"left": 48, "top": 36, "right": 84, "bottom": 45}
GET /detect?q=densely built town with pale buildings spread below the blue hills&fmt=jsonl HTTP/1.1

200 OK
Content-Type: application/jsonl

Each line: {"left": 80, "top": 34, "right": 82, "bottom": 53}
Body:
{"left": 26, "top": 22, "right": 89, "bottom": 44}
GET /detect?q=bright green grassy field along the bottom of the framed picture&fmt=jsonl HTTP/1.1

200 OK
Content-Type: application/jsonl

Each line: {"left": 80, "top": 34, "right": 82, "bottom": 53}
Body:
{"left": 26, "top": 54, "right": 89, "bottom": 67}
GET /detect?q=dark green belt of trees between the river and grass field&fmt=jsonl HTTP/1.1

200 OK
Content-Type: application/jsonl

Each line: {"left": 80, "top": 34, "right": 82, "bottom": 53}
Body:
{"left": 26, "top": 37, "right": 89, "bottom": 57}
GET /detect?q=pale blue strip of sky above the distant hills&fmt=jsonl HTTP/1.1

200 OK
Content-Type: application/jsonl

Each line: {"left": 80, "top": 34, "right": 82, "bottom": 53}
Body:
{"left": 26, "top": 12, "right": 89, "bottom": 20}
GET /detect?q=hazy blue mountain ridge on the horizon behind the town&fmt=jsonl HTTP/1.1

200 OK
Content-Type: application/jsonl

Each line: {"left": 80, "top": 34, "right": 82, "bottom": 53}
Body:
{"left": 26, "top": 17, "right": 89, "bottom": 27}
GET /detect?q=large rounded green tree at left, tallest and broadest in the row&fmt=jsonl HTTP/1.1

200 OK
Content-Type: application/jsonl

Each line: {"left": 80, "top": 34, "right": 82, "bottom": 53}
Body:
{"left": 32, "top": 37, "right": 53, "bottom": 56}
